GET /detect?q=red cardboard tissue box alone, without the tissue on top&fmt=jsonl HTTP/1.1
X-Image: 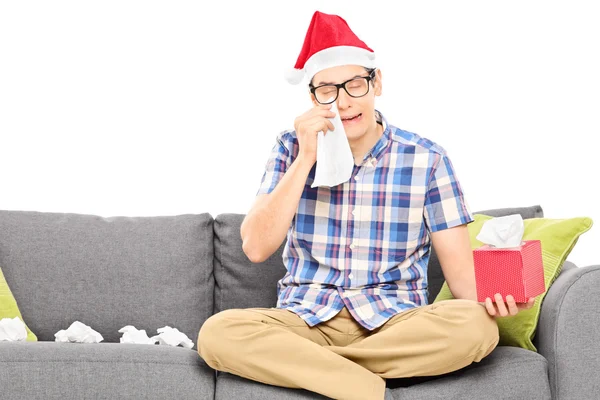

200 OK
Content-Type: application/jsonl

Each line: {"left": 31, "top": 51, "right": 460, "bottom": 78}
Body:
{"left": 473, "top": 240, "right": 546, "bottom": 303}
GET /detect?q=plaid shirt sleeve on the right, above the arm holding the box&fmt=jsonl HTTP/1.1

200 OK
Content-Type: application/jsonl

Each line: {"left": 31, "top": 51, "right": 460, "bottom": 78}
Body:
{"left": 424, "top": 152, "right": 474, "bottom": 232}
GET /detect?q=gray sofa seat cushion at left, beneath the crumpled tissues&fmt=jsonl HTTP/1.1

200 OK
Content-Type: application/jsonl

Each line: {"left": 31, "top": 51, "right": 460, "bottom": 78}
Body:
{"left": 0, "top": 341, "right": 215, "bottom": 400}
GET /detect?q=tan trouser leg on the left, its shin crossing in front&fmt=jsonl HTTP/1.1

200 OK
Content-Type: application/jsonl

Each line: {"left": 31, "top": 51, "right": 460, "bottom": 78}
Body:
{"left": 198, "top": 308, "right": 385, "bottom": 400}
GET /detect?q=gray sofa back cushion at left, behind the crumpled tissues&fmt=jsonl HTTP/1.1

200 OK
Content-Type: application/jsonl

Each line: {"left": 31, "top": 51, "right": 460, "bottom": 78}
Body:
{"left": 0, "top": 210, "right": 214, "bottom": 344}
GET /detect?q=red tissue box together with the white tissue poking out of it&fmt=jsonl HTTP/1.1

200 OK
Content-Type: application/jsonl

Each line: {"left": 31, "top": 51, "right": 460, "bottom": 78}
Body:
{"left": 473, "top": 214, "right": 546, "bottom": 303}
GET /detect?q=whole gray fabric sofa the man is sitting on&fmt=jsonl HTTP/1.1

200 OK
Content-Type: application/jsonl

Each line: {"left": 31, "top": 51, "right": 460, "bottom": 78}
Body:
{"left": 0, "top": 206, "right": 600, "bottom": 400}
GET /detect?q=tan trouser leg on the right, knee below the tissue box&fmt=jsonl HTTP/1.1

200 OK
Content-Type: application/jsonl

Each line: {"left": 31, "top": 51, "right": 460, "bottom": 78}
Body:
{"left": 325, "top": 299, "right": 499, "bottom": 379}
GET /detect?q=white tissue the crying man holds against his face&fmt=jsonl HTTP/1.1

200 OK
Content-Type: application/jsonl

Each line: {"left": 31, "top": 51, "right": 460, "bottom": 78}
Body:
{"left": 311, "top": 102, "right": 354, "bottom": 188}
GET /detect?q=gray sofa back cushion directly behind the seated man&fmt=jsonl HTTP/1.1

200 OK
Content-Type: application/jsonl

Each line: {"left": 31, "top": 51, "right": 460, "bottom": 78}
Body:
{"left": 214, "top": 205, "right": 543, "bottom": 313}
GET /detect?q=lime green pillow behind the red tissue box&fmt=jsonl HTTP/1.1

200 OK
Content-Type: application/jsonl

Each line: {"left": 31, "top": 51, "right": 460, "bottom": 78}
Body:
{"left": 434, "top": 214, "right": 593, "bottom": 352}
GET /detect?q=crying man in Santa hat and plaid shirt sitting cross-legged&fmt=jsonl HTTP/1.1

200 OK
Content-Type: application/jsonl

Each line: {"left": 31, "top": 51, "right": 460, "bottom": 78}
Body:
{"left": 198, "top": 12, "right": 533, "bottom": 400}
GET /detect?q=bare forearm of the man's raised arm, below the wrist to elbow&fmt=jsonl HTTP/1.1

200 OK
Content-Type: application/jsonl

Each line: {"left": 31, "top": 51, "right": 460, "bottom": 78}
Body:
{"left": 240, "top": 156, "right": 314, "bottom": 263}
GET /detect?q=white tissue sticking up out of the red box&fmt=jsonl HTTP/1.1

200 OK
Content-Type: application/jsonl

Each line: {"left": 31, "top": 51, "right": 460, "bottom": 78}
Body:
{"left": 477, "top": 214, "right": 525, "bottom": 248}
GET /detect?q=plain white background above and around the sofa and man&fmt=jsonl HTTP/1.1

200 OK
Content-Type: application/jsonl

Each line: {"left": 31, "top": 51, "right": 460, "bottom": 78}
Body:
{"left": 0, "top": 0, "right": 600, "bottom": 266}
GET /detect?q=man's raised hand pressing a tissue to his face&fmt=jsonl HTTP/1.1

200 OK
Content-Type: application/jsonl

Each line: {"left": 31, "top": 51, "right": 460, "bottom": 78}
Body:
{"left": 294, "top": 104, "right": 335, "bottom": 166}
